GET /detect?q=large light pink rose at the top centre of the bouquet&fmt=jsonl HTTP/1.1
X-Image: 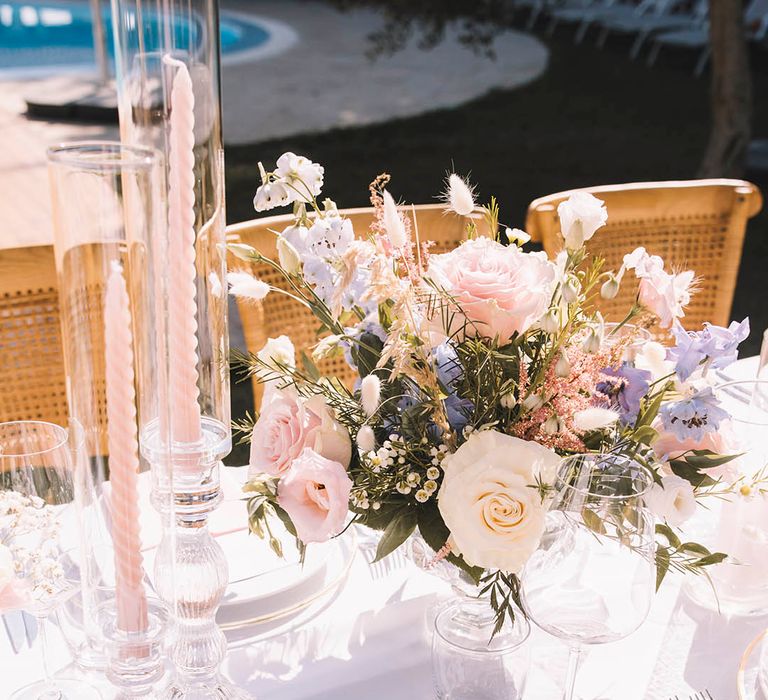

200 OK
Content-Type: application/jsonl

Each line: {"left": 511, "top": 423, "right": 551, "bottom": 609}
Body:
{"left": 427, "top": 238, "right": 555, "bottom": 342}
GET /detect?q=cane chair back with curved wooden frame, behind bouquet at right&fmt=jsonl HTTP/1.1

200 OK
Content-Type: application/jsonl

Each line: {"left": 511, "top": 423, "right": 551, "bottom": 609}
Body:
{"left": 526, "top": 179, "right": 762, "bottom": 330}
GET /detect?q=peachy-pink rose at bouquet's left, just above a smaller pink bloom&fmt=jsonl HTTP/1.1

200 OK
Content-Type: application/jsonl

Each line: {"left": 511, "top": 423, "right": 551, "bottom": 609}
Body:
{"left": 249, "top": 389, "right": 352, "bottom": 476}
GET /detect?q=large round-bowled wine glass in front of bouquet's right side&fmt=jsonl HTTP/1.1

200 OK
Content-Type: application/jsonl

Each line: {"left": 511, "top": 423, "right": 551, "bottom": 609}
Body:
{"left": 521, "top": 454, "right": 656, "bottom": 700}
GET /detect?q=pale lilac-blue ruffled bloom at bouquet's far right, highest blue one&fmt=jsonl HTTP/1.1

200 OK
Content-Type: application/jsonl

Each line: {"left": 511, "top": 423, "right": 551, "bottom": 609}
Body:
{"left": 667, "top": 318, "right": 749, "bottom": 381}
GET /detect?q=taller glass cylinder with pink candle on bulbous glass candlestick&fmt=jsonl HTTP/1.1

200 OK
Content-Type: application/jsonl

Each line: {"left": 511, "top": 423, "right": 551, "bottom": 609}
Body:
{"left": 112, "top": 0, "right": 240, "bottom": 699}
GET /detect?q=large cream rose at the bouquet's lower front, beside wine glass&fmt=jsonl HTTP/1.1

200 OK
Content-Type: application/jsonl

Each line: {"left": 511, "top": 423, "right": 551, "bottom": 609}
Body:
{"left": 438, "top": 430, "right": 560, "bottom": 573}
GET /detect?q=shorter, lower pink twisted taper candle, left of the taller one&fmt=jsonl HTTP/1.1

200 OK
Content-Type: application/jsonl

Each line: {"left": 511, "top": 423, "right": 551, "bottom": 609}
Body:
{"left": 104, "top": 261, "right": 147, "bottom": 632}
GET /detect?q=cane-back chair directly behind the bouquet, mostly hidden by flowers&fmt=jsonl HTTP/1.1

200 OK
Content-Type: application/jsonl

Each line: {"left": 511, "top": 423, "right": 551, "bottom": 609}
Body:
{"left": 227, "top": 204, "right": 488, "bottom": 408}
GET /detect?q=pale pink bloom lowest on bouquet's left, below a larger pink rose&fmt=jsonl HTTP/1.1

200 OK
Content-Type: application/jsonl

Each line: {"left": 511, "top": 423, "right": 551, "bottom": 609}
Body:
{"left": 277, "top": 448, "right": 352, "bottom": 544}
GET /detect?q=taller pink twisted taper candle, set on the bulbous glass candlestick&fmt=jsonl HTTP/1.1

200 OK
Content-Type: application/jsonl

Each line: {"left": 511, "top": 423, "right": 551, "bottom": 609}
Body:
{"left": 165, "top": 56, "right": 201, "bottom": 456}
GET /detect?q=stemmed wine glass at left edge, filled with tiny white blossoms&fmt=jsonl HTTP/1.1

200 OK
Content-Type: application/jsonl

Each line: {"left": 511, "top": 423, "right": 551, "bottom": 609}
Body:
{"left": 0, "top": 421, "right": 101, "bottom": 700}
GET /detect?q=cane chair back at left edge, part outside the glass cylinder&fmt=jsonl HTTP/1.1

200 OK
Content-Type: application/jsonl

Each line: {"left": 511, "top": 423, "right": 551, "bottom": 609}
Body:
{"left": 0, "top": 246, "right": 67, "bottom": 426}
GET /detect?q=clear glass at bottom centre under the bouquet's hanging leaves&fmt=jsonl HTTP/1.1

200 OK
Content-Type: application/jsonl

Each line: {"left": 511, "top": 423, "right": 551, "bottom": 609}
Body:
{"left": 432, "top": 598, "right": 531, "bottom": 700}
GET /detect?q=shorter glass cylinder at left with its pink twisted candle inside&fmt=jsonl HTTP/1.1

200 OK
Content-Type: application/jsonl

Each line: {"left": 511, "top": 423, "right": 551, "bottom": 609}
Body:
{"left": 48, "top": 142, "right": 171, "bottom": 680}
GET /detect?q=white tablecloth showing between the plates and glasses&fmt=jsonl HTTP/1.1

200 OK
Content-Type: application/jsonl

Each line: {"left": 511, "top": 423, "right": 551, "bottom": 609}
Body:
{"left": 0, "top": 360, "right": 768, "bottom": 700}
